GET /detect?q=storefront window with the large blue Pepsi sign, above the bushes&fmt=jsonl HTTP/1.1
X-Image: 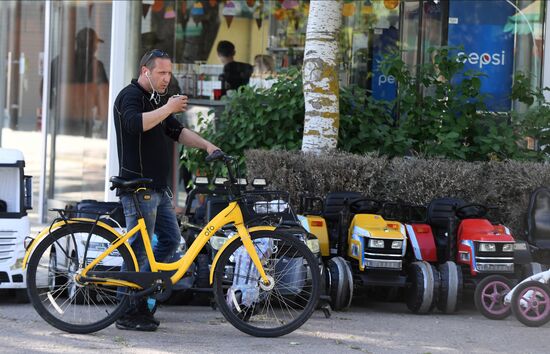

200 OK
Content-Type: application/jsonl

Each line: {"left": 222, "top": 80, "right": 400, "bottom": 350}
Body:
{"left": 418, "top": 0, "right": 544, "bottom": 112}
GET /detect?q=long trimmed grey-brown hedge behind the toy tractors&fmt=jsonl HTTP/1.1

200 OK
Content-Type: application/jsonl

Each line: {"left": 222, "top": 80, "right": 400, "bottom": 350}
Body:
{"left": 246, "top": 150, "right": 550, "bottom": 237}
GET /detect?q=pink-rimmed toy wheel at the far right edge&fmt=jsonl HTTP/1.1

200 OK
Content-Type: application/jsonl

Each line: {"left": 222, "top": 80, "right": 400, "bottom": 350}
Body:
{"left": 511, "top": 280, "right": 550, "bottom": 327}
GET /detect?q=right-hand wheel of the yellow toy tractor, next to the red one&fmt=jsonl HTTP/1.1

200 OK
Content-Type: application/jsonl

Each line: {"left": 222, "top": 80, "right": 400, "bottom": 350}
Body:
{"left": 405, "top": 261, "right": 439, "bottom": 314}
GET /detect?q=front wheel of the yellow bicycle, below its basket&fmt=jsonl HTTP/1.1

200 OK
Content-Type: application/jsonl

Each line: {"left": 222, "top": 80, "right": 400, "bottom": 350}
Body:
{"left": 214, "top": 231, "right": 320, "bottom": 337}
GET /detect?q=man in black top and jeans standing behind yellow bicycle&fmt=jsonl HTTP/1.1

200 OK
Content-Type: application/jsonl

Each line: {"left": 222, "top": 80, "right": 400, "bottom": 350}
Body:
{"left": 114, "top": 49, "right": 219, "bottom": 331}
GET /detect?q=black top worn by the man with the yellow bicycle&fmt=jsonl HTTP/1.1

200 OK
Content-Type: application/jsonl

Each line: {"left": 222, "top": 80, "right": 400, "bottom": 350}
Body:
{"left": 114, "top": 79, "right": 183, "bottom": 189}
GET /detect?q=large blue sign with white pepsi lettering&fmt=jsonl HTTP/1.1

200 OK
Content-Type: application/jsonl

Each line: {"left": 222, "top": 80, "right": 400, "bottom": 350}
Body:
{"left": 448, "top": 0, "right": 515, "bottom": 111}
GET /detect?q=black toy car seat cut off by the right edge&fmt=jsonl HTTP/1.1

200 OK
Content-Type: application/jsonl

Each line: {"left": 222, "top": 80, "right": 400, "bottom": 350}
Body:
{"left": 527, "top": 187, "right": 550, "bottom": 250}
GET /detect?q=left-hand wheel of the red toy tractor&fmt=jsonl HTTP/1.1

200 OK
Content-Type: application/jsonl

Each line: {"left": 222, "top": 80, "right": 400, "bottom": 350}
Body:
{"left": 437, "top": 261, "right": 462, "bottom": 313}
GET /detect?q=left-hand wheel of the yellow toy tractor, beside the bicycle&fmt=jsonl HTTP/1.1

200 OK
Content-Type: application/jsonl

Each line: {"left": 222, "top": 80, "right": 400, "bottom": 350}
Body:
{"left": 327, "top": 257, "right": 353, "bottom": 311}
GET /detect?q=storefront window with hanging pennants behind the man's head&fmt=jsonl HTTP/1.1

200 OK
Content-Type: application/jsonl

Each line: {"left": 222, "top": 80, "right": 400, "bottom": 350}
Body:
{"left": 140, "top": 0, "right": 272, "bottom": 100}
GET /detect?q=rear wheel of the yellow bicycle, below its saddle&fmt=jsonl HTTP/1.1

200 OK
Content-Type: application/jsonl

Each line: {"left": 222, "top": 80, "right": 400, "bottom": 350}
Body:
{"left": 27, "top": 223, "right": 135, "bottom": 333}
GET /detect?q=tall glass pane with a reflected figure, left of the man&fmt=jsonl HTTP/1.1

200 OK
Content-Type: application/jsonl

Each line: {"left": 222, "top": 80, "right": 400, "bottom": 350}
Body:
{"left": 44, "top": 1, "right": 112, "bottom": 207}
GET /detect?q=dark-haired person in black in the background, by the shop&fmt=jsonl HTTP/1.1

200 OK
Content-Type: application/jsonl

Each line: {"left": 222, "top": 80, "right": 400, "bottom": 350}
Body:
{"left": 217, "top": 41, "right": 253, "bottom": 95}
